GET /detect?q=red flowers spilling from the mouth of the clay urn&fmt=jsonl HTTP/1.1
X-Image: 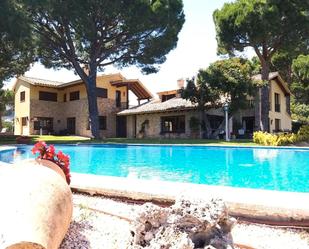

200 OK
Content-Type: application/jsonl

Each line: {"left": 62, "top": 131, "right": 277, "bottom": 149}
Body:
{"left": 31, "top": 141, "right": 71, "bottom": 184}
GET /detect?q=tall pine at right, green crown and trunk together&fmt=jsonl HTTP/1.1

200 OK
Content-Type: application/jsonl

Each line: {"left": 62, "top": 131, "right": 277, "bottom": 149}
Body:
{"left": 214, "top": 0, "right": 309, "bottom": 130}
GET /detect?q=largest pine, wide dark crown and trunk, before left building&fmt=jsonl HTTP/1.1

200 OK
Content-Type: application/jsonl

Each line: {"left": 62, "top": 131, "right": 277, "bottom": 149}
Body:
{"left": 24, "top": 0, "right": 184, "bottom": 137}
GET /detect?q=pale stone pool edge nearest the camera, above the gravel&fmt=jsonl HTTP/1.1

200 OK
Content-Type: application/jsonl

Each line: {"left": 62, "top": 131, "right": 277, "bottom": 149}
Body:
{"left": 71, "top": 173, "right": 309, "bottom": 227}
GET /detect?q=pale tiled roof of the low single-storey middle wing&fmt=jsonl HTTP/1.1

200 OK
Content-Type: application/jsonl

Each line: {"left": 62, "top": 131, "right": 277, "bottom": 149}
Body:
{"left": 118, "top": 98, "right": 197, "bottom": 115}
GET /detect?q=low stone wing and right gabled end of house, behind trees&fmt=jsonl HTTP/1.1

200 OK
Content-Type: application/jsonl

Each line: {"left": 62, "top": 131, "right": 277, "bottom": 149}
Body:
{"left": 117, "top": 73, "right": 292, "bottom": 138}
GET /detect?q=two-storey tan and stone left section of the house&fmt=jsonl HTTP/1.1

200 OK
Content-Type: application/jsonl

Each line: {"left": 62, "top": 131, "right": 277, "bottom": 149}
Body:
{"left": 13, "top": 74, "right": 152, "bottom": 137}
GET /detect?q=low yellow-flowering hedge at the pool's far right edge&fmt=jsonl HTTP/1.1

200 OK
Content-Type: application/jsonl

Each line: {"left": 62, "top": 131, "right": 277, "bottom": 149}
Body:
{"left": 253, "top": 125, "right": 309, "bottom": 146}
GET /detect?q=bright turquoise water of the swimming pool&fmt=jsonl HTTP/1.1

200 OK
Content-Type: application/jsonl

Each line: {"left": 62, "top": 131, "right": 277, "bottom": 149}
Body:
{"left": 0, "top": 145, "right": 309, "bottom": 192}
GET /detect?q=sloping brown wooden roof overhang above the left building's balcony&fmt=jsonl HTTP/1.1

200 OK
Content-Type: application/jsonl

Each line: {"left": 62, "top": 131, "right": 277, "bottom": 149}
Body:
{"left": 110, "top": 79, "right": 153, "bottom": 100}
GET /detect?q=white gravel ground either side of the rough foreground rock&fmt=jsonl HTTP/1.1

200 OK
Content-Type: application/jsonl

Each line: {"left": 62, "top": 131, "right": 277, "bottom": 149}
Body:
{"left": 60, "top": 194, "right": 309, "bottom": 249}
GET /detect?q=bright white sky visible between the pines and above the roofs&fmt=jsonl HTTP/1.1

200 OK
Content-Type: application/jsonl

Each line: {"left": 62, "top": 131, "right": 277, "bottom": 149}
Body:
{"left": 6, "top": 0, "right": 233, "bottom": 98}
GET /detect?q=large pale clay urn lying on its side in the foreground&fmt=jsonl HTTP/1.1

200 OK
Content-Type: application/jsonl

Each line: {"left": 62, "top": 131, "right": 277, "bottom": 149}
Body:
{"left": 0, "top": 160, "right": 73, "bottom": 249}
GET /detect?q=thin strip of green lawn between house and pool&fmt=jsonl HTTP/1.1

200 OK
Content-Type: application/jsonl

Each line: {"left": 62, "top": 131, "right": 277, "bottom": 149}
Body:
{"left": 0, "top": 136, "right": 257, "bottom": 146}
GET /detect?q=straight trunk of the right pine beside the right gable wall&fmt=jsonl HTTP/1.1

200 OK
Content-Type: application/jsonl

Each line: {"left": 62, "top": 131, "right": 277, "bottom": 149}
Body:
{"left": 260, "top": 61, "right": 270, "bottom": 132}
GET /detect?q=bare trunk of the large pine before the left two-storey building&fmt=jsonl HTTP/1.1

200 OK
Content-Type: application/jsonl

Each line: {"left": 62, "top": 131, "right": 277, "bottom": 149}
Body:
{"left": 85, "top": 69, "right": 100, "bottom": 139}
